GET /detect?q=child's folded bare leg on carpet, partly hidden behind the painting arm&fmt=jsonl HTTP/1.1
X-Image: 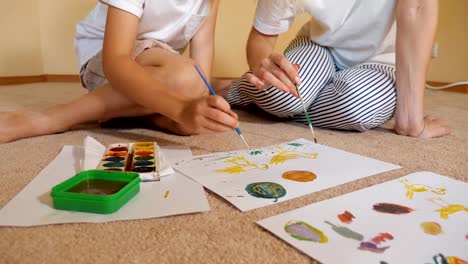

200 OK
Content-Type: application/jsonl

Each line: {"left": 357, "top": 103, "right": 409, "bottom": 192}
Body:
{"left": 0, "top": 48, "right": 208, "bottom": 143}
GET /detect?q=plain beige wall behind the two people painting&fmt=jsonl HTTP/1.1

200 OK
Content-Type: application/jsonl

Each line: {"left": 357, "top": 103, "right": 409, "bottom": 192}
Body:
{"left": 0, "top": 0, "right": 468, "bottom": 82}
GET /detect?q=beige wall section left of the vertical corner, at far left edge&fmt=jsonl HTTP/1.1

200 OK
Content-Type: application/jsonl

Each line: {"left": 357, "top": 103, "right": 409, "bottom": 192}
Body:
{"left": 0, "top": 0, "right": 43, "bottom": 76}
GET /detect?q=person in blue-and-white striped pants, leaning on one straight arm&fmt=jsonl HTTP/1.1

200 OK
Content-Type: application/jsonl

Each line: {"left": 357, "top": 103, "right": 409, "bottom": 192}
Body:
{"left": 225, "top": 0, "right": 450, "bottom": 138}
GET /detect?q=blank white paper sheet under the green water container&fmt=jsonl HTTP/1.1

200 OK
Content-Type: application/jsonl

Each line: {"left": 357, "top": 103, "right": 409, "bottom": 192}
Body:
{"left": 0, "top": 146, "right": 209, "bottom": 226}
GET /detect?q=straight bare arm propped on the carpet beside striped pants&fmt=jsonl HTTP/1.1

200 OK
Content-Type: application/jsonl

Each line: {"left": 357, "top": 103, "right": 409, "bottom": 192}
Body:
{"left": 395, "top": 0, "right": 449, "bottom": 137}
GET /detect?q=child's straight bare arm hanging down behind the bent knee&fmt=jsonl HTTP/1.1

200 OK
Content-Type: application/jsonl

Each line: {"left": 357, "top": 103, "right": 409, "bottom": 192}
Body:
{"left": 190, "top": 0, "right": 219, "bottom": 80}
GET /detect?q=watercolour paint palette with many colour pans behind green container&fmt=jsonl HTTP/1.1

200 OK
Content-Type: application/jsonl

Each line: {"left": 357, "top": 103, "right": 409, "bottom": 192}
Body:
{"left": 97, "top": 142, "right": 160, "bottom": 181}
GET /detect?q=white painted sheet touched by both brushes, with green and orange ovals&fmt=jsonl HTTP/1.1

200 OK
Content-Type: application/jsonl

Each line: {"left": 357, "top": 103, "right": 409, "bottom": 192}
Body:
{"left": 174, "top": 139, "right": 400, "bottom": 211}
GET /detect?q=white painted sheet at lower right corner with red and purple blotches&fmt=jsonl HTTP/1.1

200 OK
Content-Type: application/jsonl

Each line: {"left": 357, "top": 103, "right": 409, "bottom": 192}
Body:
{"left": 258, "top": 172, "right": 468, "bottom": 264}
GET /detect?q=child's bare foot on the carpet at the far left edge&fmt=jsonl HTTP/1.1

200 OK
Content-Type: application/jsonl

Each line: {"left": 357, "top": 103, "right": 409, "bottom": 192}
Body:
{"left": 0, "top": 111, "right": 67, "bottom": 144}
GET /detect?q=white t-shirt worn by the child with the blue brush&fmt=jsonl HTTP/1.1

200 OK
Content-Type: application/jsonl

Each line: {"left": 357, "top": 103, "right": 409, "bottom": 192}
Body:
{"left": 75, "top": 0, "right": 210, "bottom": 66}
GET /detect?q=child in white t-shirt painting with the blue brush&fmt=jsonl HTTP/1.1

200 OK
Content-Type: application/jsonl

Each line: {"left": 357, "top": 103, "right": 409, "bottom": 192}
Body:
{"left": 0, "top": 0, "right": 238, "bottom": 143}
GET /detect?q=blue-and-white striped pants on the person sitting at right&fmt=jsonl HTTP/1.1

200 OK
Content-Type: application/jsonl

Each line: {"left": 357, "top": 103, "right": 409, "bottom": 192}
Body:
{"left": 226, "top": 37, "right": 396, "bottom": 131}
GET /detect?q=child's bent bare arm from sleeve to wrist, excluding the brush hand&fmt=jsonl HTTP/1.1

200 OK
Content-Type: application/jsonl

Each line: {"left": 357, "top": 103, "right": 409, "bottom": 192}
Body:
{"left": 103, "top": 6, "right": 186, "bottom": 120}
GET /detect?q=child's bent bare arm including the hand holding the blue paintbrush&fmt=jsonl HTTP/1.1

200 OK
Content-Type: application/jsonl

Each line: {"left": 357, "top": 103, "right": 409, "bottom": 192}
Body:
{"left": 103, "top": 6, "right": 238, "bottom": 134}
